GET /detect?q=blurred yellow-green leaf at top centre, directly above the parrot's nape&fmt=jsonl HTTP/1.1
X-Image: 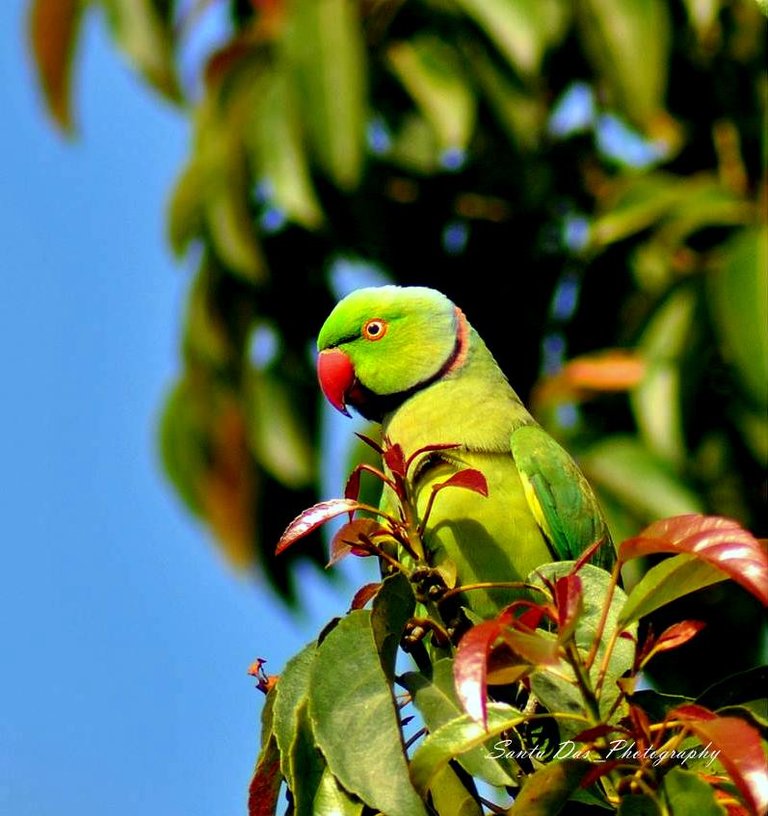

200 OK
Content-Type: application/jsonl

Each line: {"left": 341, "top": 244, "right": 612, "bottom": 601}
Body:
{"left": 387, "top": 35, "right": 476, "bottom": 150}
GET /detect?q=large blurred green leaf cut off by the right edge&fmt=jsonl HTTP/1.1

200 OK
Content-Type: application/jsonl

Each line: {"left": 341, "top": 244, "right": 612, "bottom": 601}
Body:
{"left": 708, "top": 226, "right": 768, "bottom": 408}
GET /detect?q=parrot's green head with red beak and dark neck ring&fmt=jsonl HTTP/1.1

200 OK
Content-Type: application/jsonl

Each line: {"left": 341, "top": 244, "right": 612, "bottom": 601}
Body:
{"left": 317, "top": 286, "right": 469, "bottom": 421}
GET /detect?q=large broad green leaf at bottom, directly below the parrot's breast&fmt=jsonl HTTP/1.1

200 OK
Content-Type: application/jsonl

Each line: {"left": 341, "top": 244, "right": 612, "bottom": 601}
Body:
{"left": 309, "top": 610, "right": 426, "bottom": 816}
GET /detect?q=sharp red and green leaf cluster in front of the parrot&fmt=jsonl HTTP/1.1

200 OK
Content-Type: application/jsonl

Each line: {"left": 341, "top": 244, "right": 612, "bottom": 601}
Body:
{"left": 258, "top": 440, "right": 768, "bottom": 816}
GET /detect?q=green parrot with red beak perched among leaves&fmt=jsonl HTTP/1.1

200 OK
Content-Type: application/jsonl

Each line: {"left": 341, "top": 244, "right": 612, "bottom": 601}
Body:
{"left": 317, "top": 286, "right": 615, "bottom": 617}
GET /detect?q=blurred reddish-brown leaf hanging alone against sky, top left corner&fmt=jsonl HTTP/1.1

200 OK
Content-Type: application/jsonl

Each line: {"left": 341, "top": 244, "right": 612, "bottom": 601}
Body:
{"left": 28, "top": 0, "right": 85, "bottom": 132}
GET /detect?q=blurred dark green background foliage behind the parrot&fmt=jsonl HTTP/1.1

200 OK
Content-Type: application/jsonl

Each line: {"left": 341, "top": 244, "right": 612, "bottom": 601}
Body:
{"left": 29, "top": 0, "right": 768, "bottom": 691}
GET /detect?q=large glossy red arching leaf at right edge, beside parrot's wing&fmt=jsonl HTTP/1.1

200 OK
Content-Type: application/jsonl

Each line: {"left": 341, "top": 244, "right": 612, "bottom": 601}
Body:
{"left": 619, "top": 513, "right": 768, "bottom": 606}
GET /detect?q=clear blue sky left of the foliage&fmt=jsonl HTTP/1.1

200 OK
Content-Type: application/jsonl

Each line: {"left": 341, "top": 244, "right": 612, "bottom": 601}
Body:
{"left": 0, "top": 0, "right": 353, "bottom": 816}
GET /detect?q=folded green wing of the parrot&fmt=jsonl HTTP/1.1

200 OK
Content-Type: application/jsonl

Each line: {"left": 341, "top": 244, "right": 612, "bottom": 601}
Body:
{"left": 510, "top": 425, "right": 616, "bottom": 569}
